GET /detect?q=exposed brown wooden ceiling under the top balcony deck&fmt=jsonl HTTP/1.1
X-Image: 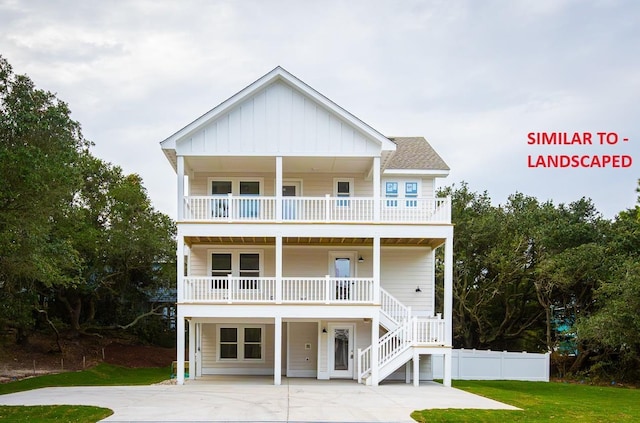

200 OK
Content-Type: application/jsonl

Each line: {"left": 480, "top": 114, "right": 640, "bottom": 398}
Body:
{"left": 186, "top": 236, "right": 444, "bottom": 248}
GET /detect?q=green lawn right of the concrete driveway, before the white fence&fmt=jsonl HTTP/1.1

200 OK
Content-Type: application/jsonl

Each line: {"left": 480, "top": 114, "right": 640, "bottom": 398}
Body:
{"left": 411, "top": 380, "right": 640, "bottom": 423}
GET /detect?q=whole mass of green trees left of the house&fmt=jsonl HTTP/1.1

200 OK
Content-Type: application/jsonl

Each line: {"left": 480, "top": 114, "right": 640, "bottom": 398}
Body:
{"left": 0, "top": 56, "right": 175, "bottom": 348}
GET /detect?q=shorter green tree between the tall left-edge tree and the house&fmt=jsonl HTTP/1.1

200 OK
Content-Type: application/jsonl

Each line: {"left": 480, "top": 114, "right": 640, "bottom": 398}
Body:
{"left": 55, "top": 158, "right": 175, "bottom": 340}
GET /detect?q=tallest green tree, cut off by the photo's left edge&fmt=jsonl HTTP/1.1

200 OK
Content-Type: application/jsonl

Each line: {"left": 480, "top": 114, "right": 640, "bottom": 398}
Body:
{"left": 0, "top": 56, "right": 89, "bottom": 340}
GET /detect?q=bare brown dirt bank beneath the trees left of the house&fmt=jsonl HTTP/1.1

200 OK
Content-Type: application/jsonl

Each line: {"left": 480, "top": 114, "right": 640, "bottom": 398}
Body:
{"left": 0, "top": 334, "right": 176, "bottom": 383}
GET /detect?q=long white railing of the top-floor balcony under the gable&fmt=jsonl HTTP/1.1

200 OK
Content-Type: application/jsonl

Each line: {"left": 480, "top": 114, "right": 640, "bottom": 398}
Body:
{"left": 183, "top": 195, "right": 451, "bottom": 223}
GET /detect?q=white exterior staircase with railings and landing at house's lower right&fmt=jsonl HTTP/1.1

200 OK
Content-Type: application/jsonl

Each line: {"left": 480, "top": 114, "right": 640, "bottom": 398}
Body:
{"left": 357, "top": 288, "right": 445, "bottom": 385}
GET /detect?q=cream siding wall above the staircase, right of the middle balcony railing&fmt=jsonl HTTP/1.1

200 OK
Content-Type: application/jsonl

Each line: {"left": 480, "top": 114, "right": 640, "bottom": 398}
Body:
{"left": 380, "top": 247, "right": 434, "bottom": 316}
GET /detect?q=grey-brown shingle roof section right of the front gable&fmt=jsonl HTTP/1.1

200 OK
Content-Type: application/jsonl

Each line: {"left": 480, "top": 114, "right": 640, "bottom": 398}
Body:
{"left": 386, "top": 137, "right": 450, "bottom": 170}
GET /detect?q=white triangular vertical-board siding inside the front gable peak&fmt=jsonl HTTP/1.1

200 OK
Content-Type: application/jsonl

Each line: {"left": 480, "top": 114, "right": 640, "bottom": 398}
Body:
{"left": 176, "top": 81, "right": 380, "bottom": 156}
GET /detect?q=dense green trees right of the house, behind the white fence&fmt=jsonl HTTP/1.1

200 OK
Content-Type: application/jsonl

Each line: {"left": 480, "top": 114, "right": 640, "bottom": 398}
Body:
{"left": 440, "top": 182, "right": 640, "bottom": 380}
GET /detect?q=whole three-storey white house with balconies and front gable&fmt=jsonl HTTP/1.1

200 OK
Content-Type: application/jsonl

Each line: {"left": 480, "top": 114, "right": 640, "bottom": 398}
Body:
{"left": 161, "top": 67, "right": 453, "bottom": 385}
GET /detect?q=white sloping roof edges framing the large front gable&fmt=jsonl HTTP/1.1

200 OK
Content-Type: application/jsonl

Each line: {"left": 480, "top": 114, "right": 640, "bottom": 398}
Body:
{"left": 160, "top": 66, "right": 396, "bottom": 167}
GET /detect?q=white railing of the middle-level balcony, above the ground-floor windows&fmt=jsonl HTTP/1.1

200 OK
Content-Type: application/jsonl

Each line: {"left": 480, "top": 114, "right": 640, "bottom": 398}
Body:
{"left": 178, "top": 276, "right": 376, "bottom": 304}
